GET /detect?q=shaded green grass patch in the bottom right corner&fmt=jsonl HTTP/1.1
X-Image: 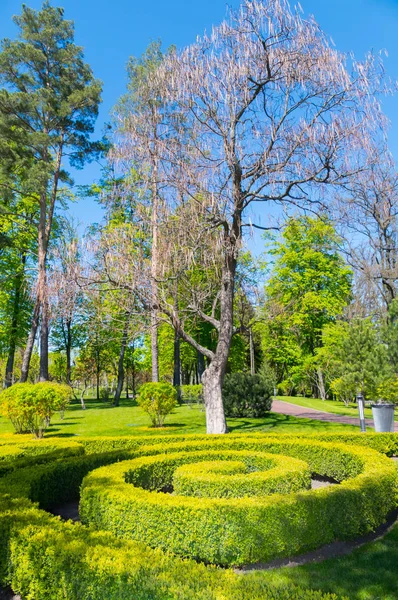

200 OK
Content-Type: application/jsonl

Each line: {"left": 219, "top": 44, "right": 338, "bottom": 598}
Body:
{"left": 248, "top": 525, "right": 398, "bottom": 600}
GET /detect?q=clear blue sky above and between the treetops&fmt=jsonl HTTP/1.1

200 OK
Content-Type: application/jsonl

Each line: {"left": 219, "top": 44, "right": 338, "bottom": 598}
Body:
{"left": 0, "top": 0, "right": 398, "bottom": 231}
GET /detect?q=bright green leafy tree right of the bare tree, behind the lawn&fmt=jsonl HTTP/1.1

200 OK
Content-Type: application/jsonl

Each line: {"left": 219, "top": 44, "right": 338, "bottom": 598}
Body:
{"left": 263, "top": 216, "right": 352, "bottom": 397}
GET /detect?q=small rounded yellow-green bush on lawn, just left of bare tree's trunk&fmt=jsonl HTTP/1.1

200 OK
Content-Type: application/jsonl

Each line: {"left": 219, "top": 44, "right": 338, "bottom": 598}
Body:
{"left": 137, "top": 383, "right": 177, "bottom": 427}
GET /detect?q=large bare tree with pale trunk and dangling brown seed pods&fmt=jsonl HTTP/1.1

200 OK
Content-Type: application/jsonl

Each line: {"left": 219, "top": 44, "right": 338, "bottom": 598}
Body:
{"left": 112, "top": 0, "right": 382, "bottom": 433}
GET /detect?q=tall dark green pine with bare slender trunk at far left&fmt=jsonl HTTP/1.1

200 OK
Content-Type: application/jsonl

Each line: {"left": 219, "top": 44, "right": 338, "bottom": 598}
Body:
{"left": 0, "top": 2, "right": 102, "bottom": 381}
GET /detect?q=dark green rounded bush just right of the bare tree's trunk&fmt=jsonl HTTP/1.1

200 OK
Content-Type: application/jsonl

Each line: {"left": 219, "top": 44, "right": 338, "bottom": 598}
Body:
{"left": 222, "top": 373, "right": 273, "bottom": 417}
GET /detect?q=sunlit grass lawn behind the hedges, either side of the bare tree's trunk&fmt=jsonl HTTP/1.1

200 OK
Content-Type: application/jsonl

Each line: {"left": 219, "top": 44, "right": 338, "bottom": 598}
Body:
{"left": 0, "top": 400, "right": 358, "bottom": 437}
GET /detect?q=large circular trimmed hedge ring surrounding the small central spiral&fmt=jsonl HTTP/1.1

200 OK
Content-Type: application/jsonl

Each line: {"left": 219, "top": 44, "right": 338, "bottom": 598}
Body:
{"left": 80, "top": 436, "right": 397, "bottom": 565}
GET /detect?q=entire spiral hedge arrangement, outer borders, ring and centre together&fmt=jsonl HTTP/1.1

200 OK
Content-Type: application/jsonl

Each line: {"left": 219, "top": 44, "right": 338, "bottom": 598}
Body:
{"left": 0, "top": 434, "right": 398, "bottom": 600}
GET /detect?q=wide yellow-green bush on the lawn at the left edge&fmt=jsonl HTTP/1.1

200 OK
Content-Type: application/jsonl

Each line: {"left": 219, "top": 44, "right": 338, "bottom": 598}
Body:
{"left": 0, "top": 382, "right": 72, "bottom": 438}
